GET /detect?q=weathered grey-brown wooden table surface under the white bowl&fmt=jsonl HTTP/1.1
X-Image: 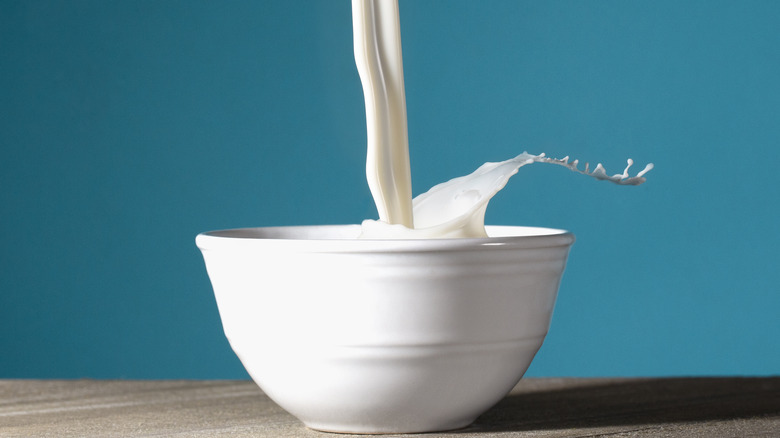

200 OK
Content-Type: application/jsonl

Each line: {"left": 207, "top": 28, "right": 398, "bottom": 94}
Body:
{"left": 0, "top": 377, "right": 780, "bottom": 438}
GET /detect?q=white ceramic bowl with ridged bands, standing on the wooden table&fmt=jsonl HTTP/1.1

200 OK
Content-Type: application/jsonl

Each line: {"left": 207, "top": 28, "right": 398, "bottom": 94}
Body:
{"left": 197, "top": 225, "right": 574, "bottom": 433}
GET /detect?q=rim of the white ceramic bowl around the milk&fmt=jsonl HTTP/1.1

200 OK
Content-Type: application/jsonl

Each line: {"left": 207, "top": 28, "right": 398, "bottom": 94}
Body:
{"left": 195, "top": 224, "right": 575, "bottom": 253}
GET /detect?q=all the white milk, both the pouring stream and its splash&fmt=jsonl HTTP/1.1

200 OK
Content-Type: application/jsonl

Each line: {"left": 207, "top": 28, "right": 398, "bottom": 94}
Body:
{"left": 352, "top": 0, "right": 653, "bottom": 239}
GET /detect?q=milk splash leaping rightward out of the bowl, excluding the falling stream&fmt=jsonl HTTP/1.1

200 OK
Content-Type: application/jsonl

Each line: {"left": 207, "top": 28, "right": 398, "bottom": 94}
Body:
{"left": 361, "top": 152, "right": 653, "bottom": 239}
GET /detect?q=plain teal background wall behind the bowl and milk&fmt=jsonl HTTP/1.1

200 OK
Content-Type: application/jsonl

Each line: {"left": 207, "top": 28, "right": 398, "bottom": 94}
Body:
{"left": 0, "top": 0, "right": 780, "bottom": 378}
